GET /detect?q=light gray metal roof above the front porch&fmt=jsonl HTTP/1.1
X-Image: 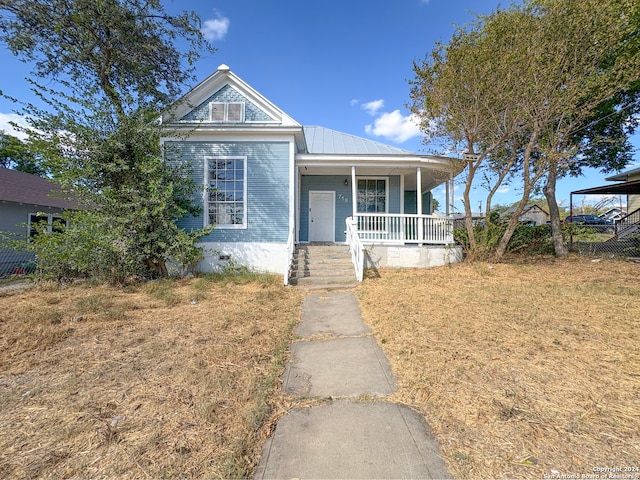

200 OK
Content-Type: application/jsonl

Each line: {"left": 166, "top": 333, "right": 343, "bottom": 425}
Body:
{"left": 303, "top": 126, "right": 415, "bottom": 155}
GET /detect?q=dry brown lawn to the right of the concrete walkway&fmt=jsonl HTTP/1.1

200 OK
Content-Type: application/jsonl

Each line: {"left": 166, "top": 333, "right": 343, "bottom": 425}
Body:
{"left": 357, "top": 257, "right": 640, "bottom": 478}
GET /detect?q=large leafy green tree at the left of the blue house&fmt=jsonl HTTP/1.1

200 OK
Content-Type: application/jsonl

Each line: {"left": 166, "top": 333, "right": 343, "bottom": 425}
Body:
{"left": 0, "top": 0, "right": 213, "bottom": 280}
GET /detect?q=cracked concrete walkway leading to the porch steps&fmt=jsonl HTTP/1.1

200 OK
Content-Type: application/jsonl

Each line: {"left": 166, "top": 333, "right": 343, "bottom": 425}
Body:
{"left": 254, "top": 292, "right": 450, "bottom": 479}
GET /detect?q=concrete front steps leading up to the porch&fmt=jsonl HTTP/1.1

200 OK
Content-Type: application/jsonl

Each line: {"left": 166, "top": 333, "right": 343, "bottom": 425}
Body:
{"left": 289, "top": 245, "right": 358, "bottom": 289}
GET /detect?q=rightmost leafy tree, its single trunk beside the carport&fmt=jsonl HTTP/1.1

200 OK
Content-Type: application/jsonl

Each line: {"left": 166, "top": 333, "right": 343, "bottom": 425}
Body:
{"left": 538, "top": 0, "right": 640, "bottom": 256}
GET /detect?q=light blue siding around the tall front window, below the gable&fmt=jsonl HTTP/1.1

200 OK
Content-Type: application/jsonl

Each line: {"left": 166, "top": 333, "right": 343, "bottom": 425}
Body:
{"left": 165, "top": 141, "right": 289, "bottom": 243}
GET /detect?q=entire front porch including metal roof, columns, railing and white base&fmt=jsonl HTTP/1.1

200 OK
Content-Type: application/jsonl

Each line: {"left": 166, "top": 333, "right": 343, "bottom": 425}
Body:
{"left": 288, "top": 127, "right": 462, "bottom": 280}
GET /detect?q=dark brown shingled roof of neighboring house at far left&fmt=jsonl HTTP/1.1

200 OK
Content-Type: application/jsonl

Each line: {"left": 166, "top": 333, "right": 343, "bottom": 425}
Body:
{"left": 0, "top": 167, "right": 77, "bottom": 208}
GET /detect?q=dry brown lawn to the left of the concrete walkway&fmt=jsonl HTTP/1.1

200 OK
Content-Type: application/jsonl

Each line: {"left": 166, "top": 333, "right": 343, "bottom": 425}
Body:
{"left": 0, "top": 277, "right": 301, "bottom": 479}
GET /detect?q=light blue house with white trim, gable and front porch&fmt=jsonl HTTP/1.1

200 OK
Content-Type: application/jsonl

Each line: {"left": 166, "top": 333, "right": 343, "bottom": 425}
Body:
{"left": 161, "top": 65, "right": 460, "bottom": 283}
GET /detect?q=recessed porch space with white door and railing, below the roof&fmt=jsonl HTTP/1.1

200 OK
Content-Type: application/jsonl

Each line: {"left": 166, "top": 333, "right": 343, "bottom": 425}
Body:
{"left": 295, "top": 166, "right": 453, "bottom": 245}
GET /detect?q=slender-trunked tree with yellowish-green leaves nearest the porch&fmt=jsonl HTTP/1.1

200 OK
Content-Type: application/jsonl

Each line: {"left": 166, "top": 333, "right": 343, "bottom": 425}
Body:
{"left": 410, "top": 4, "right": 539, "bottom": 256}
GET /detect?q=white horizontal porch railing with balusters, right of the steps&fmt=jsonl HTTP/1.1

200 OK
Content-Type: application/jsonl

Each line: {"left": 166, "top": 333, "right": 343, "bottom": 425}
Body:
{"left": 353, "top": 213, "right": 454, "bottom": 245}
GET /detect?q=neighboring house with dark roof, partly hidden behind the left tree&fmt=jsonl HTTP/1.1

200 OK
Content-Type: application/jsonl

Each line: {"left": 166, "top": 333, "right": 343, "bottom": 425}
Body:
{"left": 0, "top": 168, "right": 75, "bottom": 276}
